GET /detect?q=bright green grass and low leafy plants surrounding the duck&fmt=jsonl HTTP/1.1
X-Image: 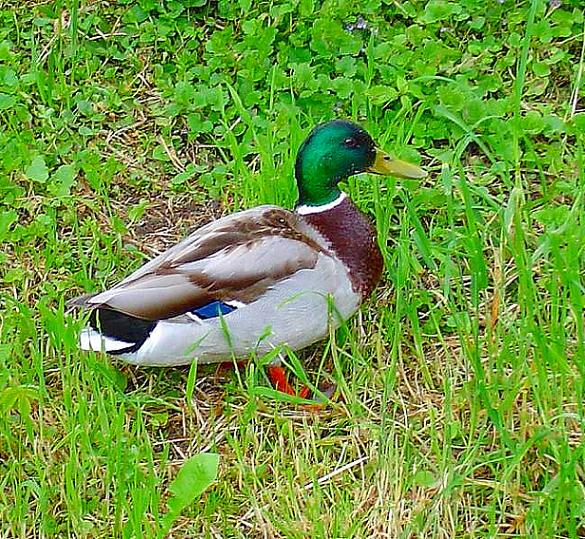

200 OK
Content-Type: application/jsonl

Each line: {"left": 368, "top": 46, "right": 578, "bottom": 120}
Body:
{"left": 0, "top": 0, "right": 585, "bottom": 538}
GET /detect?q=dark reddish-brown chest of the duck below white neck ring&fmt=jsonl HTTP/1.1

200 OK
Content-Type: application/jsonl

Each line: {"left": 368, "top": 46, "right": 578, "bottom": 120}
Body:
{"left": 303, "top": 198, "right": 384, "bottom": 298}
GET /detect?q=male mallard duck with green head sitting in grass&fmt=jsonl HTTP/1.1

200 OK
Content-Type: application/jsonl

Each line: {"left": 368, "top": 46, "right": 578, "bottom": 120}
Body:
{"left": 74, "top": 120, "right": 426, "bottom": 398}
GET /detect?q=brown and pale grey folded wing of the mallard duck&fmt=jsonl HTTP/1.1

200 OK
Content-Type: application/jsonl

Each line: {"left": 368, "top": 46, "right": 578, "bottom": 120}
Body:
{"left": 88, "top": 206, "right": 321, "bottom": 320}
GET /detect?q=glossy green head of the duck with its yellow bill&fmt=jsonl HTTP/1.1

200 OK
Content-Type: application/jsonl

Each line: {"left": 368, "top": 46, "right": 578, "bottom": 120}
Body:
{"left": 295, "top": 120, "right": 426, "bottom": 206}
